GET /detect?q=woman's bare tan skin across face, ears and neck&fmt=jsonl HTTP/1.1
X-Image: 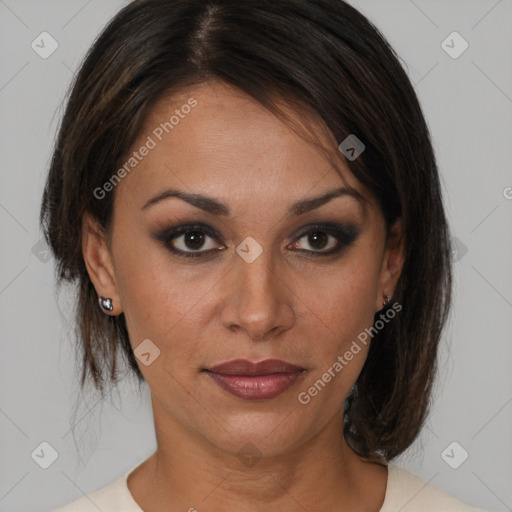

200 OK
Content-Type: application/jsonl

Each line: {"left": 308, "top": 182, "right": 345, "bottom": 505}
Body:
{"left": 83, "top": 82, "right": 403, "bottom": 512}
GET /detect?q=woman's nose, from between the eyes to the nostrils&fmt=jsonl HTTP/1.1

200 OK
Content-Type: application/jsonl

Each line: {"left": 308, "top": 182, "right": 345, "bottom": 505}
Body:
{"left": 221, "top": 246, "right": 295, "bottom": 341}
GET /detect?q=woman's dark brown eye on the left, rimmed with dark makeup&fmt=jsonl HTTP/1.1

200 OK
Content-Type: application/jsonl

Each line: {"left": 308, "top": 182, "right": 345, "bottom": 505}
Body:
{"left": 155, "top": 224, "right": 225, "bottom": 257}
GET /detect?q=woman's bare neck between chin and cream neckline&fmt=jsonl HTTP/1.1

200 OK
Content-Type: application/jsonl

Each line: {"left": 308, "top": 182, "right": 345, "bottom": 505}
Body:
{"left": 128, "top": 406, "right": 387, "bottom": 512}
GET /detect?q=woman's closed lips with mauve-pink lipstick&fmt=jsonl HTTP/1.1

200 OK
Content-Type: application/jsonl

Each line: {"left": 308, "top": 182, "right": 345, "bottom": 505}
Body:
{"left": 202, "top": 359, "right": 307, "bottom": 400}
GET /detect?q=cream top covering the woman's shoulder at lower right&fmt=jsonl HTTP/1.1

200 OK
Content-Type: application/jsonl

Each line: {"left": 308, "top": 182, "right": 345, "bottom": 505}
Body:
{"left": 380, "top": 463, "right": 485, "bottom": 512}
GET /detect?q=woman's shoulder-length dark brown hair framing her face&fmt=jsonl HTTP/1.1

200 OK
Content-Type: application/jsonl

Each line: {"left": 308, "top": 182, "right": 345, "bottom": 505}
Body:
{"left": 40, "top": 0, "right": 452, "bottom": 462}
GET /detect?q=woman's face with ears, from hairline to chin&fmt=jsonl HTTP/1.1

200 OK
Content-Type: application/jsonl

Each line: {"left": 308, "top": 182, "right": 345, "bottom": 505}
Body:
{"left": 83, "top": 82, "right": 402, "bottom": 460}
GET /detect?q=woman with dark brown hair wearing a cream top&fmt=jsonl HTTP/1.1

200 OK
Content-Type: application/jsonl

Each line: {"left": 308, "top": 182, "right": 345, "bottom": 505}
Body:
{"left": 41, "top": 0, "right": 486, "bottom": 512}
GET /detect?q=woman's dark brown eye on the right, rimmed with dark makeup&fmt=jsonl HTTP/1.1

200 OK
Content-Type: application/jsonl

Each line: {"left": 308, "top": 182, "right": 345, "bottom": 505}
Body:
{"left": 289, "top": 224, "right": 358, "bottom": 256}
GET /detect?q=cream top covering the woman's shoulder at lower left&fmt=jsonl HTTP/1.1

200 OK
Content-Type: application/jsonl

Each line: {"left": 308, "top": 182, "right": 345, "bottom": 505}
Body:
{"left": 52, "top": 473, "right": 141, "bottom": 512}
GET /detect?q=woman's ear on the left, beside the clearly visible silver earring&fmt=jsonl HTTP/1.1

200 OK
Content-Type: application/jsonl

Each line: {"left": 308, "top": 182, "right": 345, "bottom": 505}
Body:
{"left": 82, "top": 212, "right": 123, "bottom": 316}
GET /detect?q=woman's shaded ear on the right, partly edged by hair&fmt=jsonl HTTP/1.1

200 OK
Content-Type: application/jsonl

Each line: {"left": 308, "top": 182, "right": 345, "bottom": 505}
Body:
{"left": 375, "top": 219, "right": 405, "bottom": 312}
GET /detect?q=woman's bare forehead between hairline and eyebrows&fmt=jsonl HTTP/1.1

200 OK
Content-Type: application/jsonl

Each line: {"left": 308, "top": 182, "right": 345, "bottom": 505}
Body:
{"left": 114, "top": 82, "right": 369, "bottom": 214}
